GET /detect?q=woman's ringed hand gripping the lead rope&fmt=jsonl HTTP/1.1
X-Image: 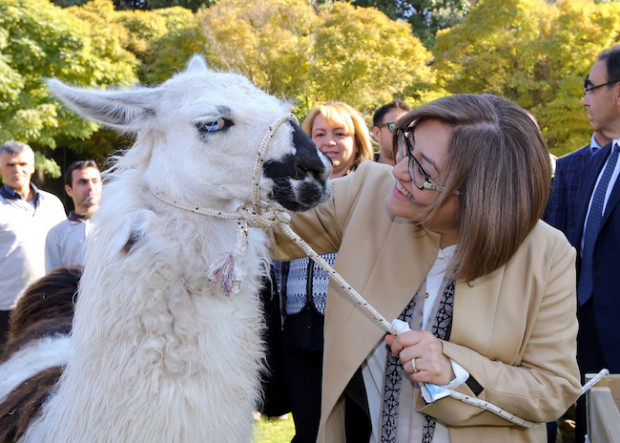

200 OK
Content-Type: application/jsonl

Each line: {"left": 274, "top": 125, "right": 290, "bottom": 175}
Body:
{"left": 385, "top": 331, "right": 456, "bottom": 385}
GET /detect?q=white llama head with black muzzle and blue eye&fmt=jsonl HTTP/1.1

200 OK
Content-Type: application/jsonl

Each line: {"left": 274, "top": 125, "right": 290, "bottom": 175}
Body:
{"left": 47, "top": 56, "right": 331, "bottom": 211}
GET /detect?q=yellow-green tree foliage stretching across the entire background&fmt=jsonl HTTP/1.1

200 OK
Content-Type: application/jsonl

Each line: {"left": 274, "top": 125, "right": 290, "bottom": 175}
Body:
{"left": 0, "top": 0, "right": 620, "bottom": 168}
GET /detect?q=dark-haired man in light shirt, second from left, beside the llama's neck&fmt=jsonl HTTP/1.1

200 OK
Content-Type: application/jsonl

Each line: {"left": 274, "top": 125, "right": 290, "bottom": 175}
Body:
{"left": 45, "top": 160, "right": 102, "bottom": 272}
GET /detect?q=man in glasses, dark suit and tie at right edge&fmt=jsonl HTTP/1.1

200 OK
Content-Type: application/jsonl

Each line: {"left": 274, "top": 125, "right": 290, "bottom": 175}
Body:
{"left": 568, "top": 46, "right": 620, "bottom": 442}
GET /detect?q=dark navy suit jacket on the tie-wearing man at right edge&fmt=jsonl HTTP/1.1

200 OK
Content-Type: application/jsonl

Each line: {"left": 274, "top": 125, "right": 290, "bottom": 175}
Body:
{"left": 568, "top": 141, "right": 620, "bottom": 373}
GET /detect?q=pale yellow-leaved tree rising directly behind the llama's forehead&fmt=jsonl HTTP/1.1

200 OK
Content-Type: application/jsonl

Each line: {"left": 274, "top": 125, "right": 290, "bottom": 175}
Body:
{"left": 197, "top": 0, "right": 317, "bottom": 115}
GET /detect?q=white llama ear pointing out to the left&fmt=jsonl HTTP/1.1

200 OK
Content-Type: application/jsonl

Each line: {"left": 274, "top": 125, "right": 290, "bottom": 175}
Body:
{"left": 45, "top": 79, "right": 160, "bottom": 132}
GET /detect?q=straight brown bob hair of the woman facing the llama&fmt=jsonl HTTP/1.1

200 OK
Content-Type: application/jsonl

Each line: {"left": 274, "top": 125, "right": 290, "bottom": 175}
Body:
{"left": 394, "top": 94, "right": 551, "bottom": 281}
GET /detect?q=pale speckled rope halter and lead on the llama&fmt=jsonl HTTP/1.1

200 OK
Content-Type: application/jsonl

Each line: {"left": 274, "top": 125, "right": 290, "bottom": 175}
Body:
{"left": 151, "top": 115, "right": 609, "bottom": 428}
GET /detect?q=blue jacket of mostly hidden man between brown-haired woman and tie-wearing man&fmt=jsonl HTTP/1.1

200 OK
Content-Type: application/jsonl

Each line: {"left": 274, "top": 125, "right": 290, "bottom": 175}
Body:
{"left": 543, "top": 144, "right": 592, "bottom": 238}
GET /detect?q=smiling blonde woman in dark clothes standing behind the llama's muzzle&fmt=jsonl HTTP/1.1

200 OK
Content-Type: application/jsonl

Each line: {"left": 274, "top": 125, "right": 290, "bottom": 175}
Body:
{"left": 275, "top": 102, "right": 373, "bottom": 443}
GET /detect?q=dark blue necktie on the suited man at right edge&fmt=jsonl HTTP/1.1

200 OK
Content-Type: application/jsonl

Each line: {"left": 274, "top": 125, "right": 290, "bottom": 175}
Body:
{"left": 577, "top": 144, "right": 620, "bottom": 306}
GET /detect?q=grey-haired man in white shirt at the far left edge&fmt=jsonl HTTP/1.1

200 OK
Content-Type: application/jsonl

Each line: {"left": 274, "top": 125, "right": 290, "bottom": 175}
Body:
{"left": 0, "top": 141, "right": 65, "bottom": 345}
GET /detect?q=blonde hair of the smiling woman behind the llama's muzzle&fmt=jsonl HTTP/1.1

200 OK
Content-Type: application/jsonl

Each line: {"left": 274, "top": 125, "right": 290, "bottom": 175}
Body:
{"left": 301, "top": 101, "right": 373, "bottom": 169}
